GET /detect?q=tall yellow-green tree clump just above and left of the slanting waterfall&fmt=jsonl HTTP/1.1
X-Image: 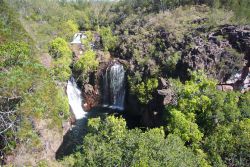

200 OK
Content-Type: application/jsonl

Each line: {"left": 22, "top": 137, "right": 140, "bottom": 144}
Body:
{"left": 49, "top": 38, "right": 72, "bottom": 81}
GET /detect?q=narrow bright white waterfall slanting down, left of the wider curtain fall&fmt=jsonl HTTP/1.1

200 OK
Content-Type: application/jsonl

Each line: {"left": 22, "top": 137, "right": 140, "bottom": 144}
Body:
{"left": 67, "top": 77, "right": 86, "bottom": 119}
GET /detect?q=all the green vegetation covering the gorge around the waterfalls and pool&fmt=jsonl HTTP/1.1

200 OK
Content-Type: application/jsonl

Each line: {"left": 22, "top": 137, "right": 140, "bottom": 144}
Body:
{"left": 0, "top": 0, "right": 250, "bottom": 167}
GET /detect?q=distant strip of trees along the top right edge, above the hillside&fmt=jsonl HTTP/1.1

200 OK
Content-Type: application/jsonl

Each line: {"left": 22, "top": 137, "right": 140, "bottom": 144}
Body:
{"left": 114, "top": 0, "right": 250, "bottom": 20}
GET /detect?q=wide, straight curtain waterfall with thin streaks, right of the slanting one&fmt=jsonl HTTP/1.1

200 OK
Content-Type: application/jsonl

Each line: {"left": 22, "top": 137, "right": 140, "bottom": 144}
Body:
{"left": 103, "top": 63, "right": 125, "bottom": 110}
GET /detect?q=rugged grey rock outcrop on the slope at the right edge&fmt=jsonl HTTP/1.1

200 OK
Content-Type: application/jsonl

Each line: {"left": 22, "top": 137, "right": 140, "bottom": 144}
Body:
{"left": 180, "top": 25, "right": 250, "bottom": 91}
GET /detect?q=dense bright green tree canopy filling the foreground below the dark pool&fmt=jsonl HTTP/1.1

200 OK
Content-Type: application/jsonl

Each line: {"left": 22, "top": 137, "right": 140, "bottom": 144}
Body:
{"left": 63, "top": 72, "right": 250, "bottom": 166}
